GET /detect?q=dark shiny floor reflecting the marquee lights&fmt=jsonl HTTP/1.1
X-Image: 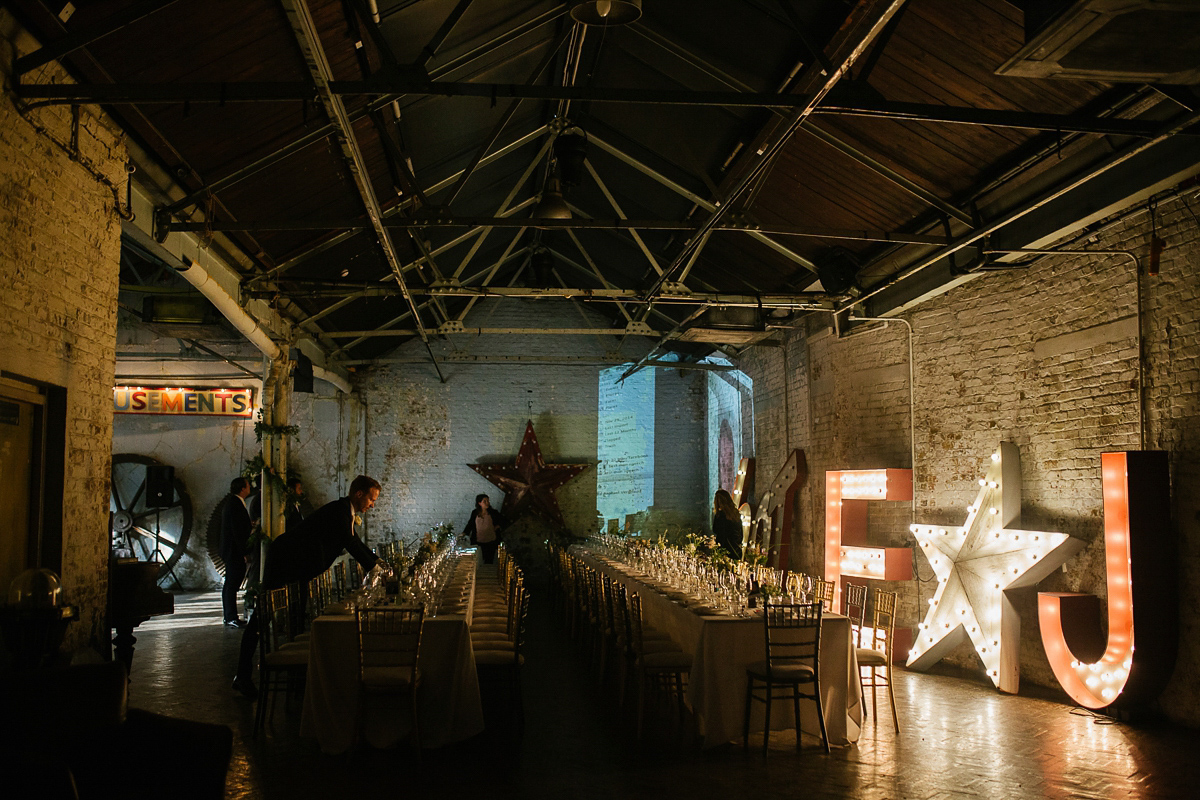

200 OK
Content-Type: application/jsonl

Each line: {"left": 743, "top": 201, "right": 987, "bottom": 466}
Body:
{"left": 131, "top": 593, "right": 1200, "bottom": 800}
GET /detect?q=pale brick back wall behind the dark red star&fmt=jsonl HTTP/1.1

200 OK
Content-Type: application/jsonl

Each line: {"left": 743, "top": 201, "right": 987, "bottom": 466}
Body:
{"left": 361, "top": 300, "right": 707, "bottom": 541}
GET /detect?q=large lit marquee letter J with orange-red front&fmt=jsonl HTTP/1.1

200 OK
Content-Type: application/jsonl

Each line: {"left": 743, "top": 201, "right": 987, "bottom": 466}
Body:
{"left": 1038, "top": 451, "right": 1178, "bottom": 711}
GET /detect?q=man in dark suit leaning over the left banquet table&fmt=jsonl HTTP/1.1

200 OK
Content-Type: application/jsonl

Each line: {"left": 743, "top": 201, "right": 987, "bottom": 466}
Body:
{"left": 233, "top": 475, "right": 382, "bottom": 697}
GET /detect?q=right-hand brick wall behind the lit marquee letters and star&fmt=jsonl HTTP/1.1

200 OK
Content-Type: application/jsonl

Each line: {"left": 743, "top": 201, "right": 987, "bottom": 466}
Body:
{"left": 742, "top": 190, "right": 1200, "bottom": 724}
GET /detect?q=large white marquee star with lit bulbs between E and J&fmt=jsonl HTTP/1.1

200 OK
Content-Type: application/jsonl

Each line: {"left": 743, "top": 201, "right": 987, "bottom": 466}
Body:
{"left": 908, "top": 441, "right": 1084, "bottom": 692}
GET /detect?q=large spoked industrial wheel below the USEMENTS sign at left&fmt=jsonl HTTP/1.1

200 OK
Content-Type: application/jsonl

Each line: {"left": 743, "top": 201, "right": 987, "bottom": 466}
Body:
{"left": 108, "top": 453, "right": 192, "bottom": 581}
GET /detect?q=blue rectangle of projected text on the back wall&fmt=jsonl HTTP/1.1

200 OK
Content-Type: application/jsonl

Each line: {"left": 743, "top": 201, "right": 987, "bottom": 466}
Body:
{"left": 596, "top": 365, "right": 654, "bottom": 521}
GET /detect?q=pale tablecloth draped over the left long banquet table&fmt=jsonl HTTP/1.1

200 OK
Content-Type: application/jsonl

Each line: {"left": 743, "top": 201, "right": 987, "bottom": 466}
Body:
{"left": 300, "top": 551, "right": 484, "bottom": 753}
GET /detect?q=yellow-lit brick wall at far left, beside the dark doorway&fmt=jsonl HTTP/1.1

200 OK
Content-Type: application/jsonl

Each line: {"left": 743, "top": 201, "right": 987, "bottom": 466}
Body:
{"left": 0, "top": 12, "right": 125, "bottom": 649}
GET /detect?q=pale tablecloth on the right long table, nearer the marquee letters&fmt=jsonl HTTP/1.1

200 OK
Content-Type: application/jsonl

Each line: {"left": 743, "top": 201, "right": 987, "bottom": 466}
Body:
{"left": 571, "top": 545, "right": 863, "bottom": 747}
